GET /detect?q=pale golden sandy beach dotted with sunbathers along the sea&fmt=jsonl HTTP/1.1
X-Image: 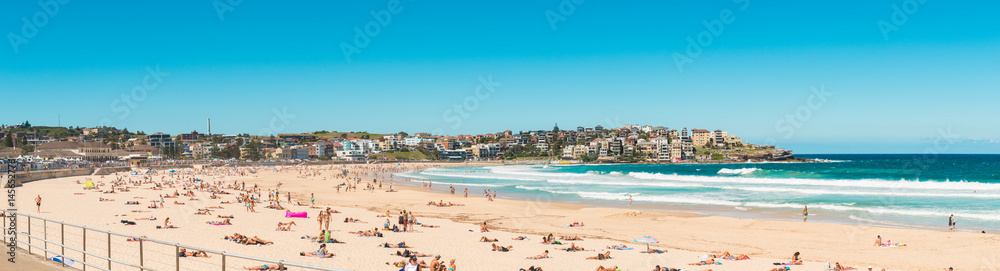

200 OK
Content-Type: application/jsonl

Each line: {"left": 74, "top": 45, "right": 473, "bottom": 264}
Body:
{"left": 5, "top": 164, "right": 1000, "bottom": 270}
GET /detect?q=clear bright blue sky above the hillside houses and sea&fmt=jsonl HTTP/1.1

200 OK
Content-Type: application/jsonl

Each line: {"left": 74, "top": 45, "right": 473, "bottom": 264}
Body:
{"left": 0, "top": 0, "right": 1000, "bottom": 153}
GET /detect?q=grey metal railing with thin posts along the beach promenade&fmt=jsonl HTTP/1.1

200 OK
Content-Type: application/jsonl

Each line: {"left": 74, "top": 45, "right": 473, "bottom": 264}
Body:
{"left": 0, "top": 211, "right": 346, "bottom": 271}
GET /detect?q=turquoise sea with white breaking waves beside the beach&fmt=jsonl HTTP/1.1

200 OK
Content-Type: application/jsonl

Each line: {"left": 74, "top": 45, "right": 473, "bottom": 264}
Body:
{"left": 403, "top": 155, "right": 1000, "bottom": 232}
